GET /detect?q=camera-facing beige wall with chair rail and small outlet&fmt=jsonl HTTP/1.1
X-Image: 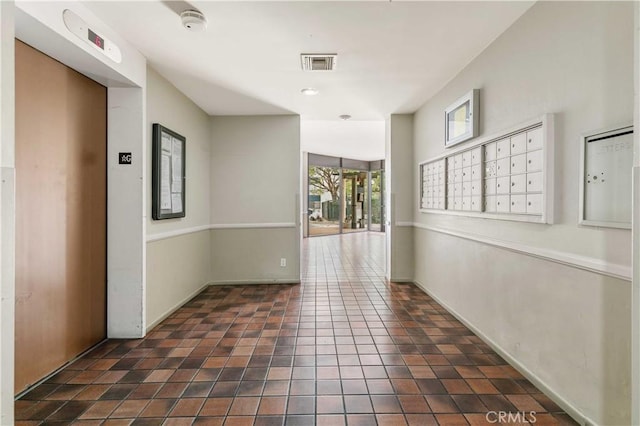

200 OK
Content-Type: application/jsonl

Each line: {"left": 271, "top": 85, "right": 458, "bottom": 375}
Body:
{"left": 210, "top": 115, "right": 301, "bottom": 283}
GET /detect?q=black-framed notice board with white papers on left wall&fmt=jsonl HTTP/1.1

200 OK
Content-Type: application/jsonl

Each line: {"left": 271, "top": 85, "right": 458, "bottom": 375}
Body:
{"left": 151, "top": 123, "right": 186, "bottom": 220}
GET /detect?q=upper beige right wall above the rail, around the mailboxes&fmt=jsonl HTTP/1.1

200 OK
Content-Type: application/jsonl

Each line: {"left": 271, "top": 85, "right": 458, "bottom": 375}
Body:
{"left": 414, "top": 2, "right": 633, "bottom": 265}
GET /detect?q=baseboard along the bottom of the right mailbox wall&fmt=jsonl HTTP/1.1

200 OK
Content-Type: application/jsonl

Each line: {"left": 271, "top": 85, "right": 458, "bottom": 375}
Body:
{"left": 414, "top": 281, "right": 597, "bottom": 426}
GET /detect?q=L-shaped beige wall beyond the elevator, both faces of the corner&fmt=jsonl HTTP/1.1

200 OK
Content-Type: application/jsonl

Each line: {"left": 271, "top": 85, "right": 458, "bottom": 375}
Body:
{"left": 146, "top": 84, "right": 300, "bottom": 326}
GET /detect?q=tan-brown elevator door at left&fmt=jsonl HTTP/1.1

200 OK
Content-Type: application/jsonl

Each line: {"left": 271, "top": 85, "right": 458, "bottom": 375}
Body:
{"left": 15, "top": 40, "right": 107, "bottom": 393}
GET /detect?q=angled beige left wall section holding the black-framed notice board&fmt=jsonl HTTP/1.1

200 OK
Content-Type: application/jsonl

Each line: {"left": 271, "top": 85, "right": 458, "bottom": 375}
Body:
{"left": 146, "top": 67, "right": 211, "bottom": 328}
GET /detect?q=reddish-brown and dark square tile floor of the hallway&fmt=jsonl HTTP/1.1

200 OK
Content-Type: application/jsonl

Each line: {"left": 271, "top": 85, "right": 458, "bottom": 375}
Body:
{"left": 16, "top": 233, "right": 573, "bottom": 426}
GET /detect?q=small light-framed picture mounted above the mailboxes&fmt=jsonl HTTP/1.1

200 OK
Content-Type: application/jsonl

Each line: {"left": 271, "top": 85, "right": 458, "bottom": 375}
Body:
{"left": 444, "top": 89, "right": 480, "bottom": 148}
